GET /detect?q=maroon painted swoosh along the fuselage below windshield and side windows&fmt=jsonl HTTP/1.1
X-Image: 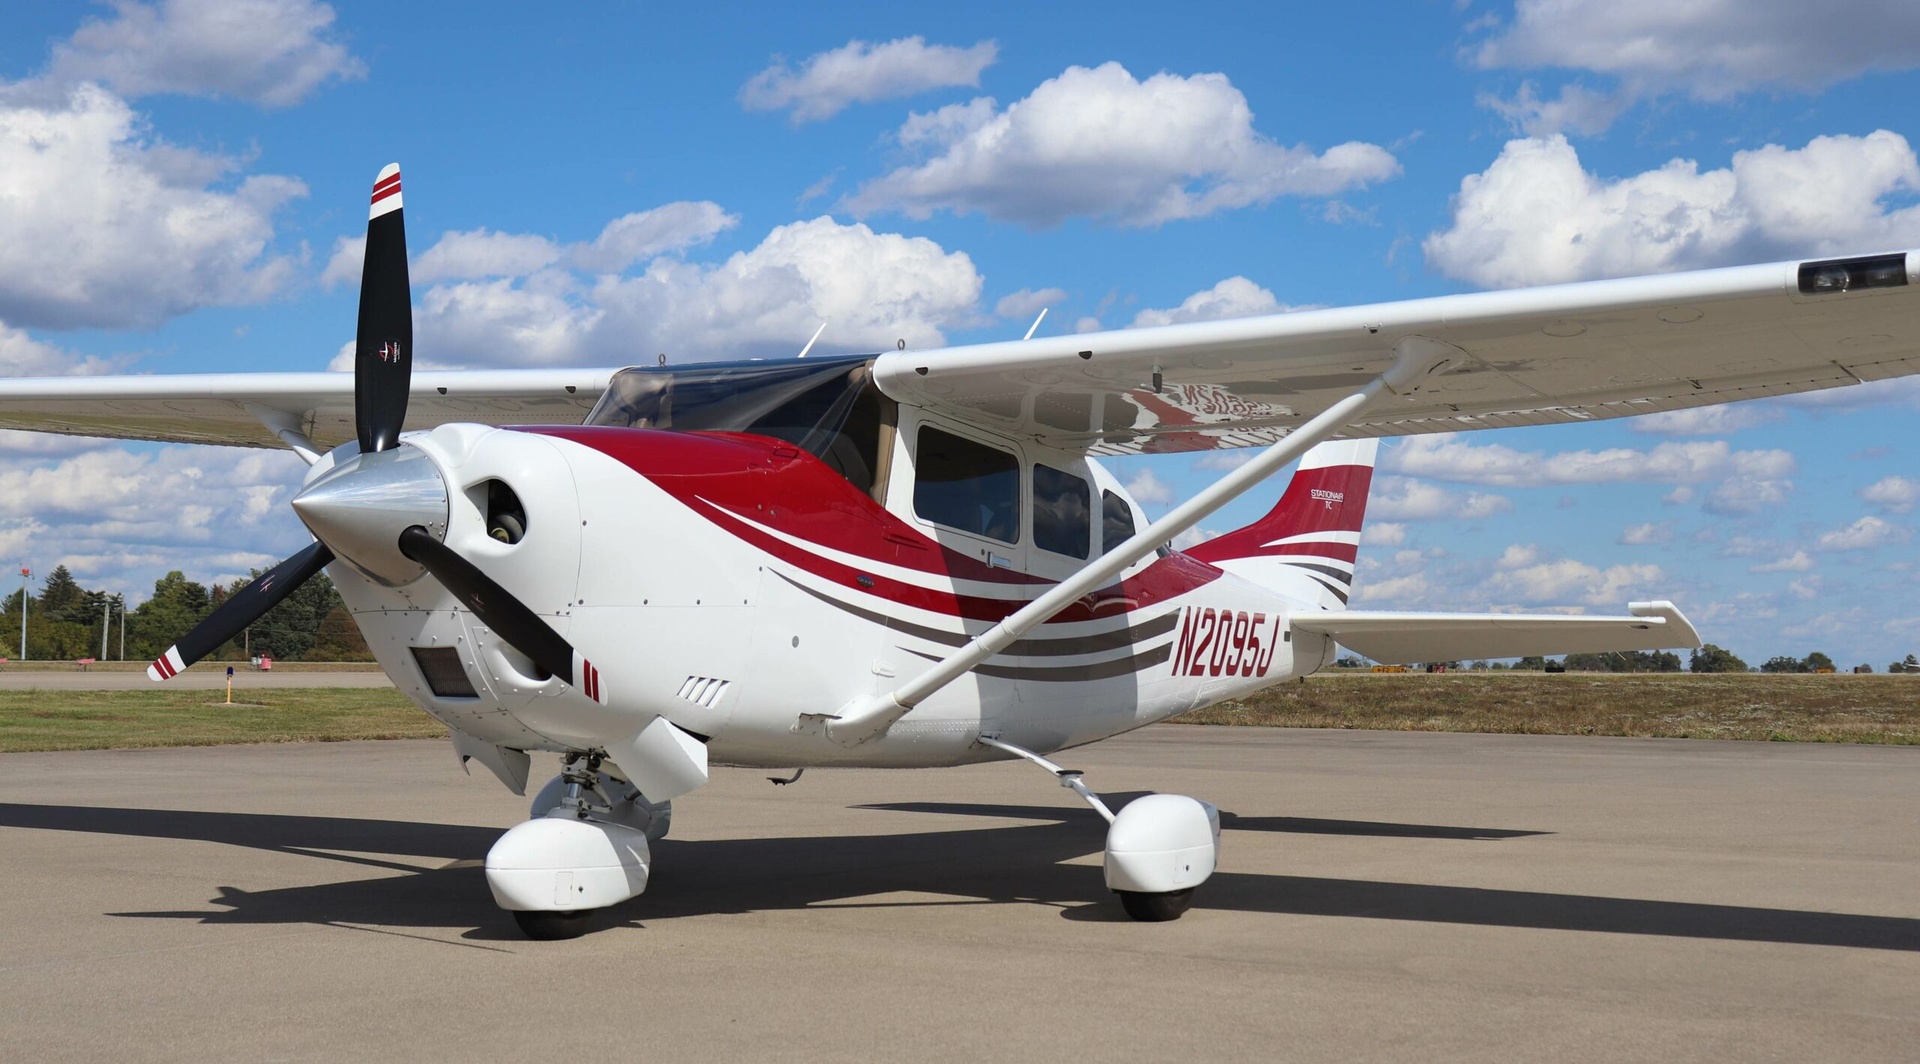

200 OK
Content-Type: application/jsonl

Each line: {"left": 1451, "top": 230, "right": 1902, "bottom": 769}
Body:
{"left": 524, "top": 424, "right": 1221, "bottom": 624}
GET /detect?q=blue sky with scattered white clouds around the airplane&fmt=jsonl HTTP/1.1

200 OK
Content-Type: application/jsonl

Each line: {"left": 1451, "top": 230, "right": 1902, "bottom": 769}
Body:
{"left": 0, "top": 0, "right": 1920, "bottom": 668}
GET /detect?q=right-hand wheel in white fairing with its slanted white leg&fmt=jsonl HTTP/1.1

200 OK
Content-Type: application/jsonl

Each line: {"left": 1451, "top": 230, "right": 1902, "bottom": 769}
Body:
{"left": 979, "top": 736, "right": 1219, "bottom": 922}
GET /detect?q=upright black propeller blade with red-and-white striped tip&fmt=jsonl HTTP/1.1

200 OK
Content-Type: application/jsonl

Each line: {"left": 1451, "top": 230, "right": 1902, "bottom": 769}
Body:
{"left": 353, "top": 163, "right": 413, "bottom": 453}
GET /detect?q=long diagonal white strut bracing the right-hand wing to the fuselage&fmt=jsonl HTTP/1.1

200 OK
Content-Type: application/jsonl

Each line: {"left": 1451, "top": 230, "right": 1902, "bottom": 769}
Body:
{"left": 817, "top": 336, "right": 1467, "bottom": 745}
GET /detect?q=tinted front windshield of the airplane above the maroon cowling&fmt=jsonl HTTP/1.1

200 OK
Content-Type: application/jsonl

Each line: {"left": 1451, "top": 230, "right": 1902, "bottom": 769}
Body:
{"left": 586, "top": 355, "right": 891, "bottom": 494}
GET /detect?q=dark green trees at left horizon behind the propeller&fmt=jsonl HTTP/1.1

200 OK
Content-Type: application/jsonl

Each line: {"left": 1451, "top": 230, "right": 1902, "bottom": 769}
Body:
{"left": 0, "top": 565, "right": 372, "bottom": 661}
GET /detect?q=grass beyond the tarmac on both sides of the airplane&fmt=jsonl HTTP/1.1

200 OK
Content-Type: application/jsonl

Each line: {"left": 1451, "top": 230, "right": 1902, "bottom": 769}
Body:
{"left": 0, "top": 672, "right": 1920, "bottom": 753}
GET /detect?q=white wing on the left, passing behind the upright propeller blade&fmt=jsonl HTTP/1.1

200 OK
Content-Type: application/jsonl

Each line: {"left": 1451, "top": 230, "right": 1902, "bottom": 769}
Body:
{"left": 0, "top": 369, "right": 614, "bottom": 449}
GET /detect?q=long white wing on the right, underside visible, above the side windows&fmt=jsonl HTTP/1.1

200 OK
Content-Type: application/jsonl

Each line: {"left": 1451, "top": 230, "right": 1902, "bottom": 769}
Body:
{"left": 874, "top": 252, "right": 1920, "bottom": 453}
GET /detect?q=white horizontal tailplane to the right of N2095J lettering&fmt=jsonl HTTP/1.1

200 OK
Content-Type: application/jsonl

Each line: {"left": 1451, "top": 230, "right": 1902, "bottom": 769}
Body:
{"left": 1290, "top": 601, "right": 1699, "bottom": 665}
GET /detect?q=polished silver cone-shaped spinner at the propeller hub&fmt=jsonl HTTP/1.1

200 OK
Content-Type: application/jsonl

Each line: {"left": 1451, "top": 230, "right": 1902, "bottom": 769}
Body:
{"left": 294, "top": 446, "right": 447, "bottom": 586}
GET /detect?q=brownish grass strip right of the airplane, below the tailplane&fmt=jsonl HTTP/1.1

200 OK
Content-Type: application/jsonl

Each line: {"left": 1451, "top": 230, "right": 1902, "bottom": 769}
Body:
{"left": 1181, "top": 672, "right": 1920, "bottom": 743}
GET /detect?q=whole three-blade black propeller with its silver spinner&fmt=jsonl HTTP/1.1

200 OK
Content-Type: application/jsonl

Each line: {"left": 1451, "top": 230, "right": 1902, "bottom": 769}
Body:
{"left": 146, "top": 163, "right": 607, "bottom": 701}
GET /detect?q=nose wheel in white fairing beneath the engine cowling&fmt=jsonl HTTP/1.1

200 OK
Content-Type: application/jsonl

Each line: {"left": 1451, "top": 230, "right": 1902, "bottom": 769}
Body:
{"left": 486, "top": 751, "right": 674, "bottom": 939}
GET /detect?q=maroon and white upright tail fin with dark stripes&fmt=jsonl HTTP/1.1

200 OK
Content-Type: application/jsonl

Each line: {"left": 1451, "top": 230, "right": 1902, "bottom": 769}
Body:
{"left": 1187, "top": 440, "right": 1380, "bottom": 609}
